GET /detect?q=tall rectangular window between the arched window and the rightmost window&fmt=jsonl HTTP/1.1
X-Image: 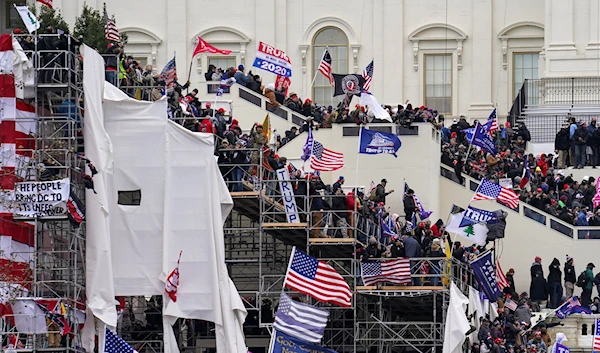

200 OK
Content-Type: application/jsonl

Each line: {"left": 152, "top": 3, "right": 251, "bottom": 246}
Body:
{"left": 424, "top": 54, "right": 452, "bottom": 114}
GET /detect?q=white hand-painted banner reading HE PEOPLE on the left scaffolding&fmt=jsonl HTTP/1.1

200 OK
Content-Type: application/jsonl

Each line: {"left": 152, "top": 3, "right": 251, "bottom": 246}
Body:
{"left": 13, "top": 179, "right": 71, "bottom": 218}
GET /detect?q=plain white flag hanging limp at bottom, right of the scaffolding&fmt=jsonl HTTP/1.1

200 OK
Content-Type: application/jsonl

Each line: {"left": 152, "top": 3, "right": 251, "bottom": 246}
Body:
{"left": 442, "top": 282, "right": 471, "bottom": 353}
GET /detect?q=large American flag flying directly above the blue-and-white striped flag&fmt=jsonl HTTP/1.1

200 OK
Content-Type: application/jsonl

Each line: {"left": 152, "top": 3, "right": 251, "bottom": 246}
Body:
{"left": 284, "top": 247, "right": 352, "bottom": 307}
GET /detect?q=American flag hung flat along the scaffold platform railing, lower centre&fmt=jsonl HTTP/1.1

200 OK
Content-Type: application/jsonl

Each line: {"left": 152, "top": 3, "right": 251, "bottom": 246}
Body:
{"left": 360, "top": 259, "right": 411, "bottom": 286}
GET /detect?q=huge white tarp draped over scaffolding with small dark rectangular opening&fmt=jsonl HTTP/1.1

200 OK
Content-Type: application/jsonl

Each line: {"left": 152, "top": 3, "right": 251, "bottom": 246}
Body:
{"left": 84, "top": 48, "right": 247, "bottom": 353}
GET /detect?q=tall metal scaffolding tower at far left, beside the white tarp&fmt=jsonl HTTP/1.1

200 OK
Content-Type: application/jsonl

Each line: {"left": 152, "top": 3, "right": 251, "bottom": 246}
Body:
{"left": 0, "top": 35, "right": 85, "bottom": 351}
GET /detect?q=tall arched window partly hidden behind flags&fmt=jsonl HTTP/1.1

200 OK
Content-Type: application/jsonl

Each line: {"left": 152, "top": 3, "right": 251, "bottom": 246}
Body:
{"left": 312, "top": 27, "right": 348, "bottom": 107}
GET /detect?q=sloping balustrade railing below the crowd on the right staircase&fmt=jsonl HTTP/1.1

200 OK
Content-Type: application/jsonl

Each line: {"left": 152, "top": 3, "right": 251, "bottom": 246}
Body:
{"left": 440, "top": 163, "right": 600, "bottom": 240}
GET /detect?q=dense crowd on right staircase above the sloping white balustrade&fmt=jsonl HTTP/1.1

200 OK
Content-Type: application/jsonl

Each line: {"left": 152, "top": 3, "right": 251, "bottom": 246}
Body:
{"left": 441, "top": 117, "right": 600, "bottom": 226}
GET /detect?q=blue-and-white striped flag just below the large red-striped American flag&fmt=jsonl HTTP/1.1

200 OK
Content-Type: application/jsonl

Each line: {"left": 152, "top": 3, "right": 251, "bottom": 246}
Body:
{"left": 273, "top": 293, "right": 329, "bottom": 343}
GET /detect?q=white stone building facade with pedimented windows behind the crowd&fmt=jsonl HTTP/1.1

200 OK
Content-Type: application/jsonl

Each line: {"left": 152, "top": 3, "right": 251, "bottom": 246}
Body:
{"left": 0, "top": 0, "right": 600, "bottom": 118}
